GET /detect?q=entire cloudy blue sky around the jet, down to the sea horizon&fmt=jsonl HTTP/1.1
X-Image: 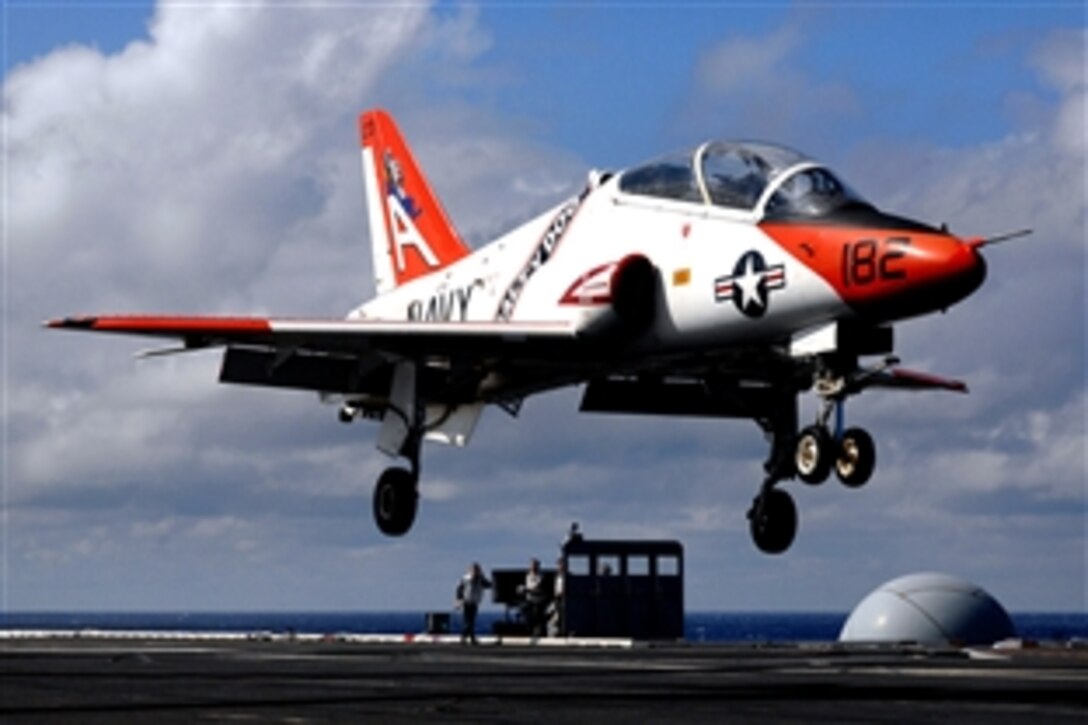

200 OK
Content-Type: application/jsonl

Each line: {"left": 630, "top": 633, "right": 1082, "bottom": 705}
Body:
{"left": 2, "top": 2, "right": 1088, "bottom": 611}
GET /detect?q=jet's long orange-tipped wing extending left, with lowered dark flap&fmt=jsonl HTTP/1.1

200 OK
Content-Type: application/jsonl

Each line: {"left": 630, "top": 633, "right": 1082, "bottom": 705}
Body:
{"left": 46, "top": 316, "right": 581, "bottom": 400}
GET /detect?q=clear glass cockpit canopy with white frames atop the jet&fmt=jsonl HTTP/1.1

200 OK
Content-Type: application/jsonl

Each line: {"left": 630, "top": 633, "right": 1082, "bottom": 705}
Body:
{"left": 619, "top": 142, "right": 871, "bottom": 219}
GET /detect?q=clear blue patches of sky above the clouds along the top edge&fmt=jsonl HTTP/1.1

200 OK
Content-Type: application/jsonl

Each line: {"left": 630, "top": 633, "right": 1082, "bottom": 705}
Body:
{"left": 4, "top": 2, "right": 1085, "bottom": 156}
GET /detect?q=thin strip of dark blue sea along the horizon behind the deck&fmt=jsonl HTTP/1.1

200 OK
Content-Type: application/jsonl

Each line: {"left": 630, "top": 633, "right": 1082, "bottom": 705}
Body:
{"left": 0, "top": 611, "right": 1088, "bottom": 642}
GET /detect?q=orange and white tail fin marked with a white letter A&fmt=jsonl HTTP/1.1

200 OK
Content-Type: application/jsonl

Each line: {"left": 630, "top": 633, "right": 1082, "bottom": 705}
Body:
{"left": 359, "top": 110, "right": 470, "bottom": 294}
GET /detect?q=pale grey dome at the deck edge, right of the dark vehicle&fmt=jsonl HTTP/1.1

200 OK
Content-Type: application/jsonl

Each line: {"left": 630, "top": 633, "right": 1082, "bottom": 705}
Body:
{"left": 839, "top": 574, "right": 1016, "bottom": 647}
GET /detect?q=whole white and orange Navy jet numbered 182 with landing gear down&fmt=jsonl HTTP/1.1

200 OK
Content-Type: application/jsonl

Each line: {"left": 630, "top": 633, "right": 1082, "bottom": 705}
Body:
{"left": 47, "top": 110, "right": 1013, "bottom": 553}
